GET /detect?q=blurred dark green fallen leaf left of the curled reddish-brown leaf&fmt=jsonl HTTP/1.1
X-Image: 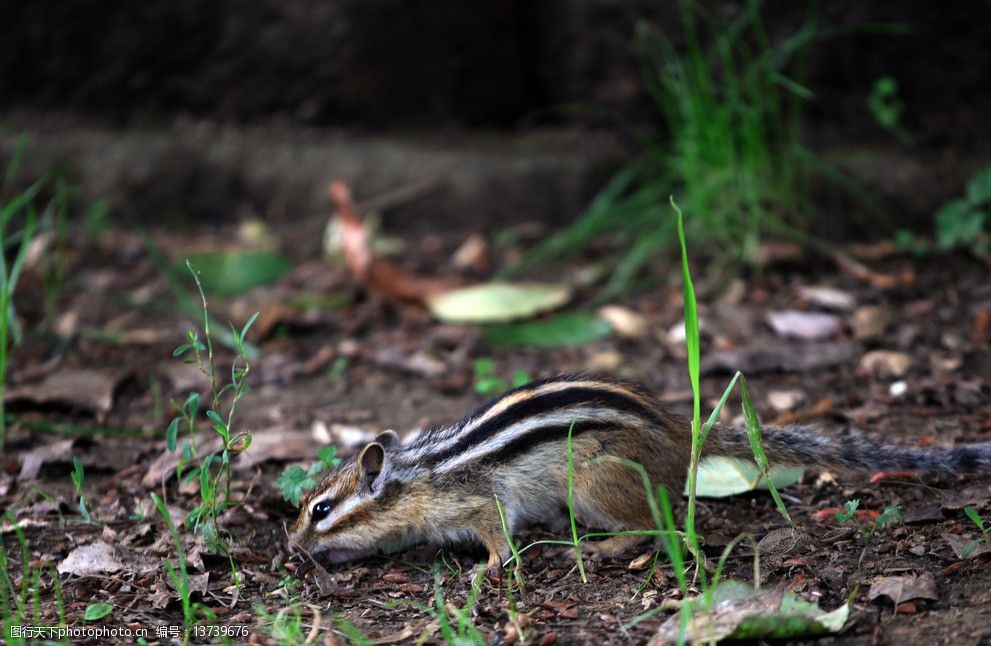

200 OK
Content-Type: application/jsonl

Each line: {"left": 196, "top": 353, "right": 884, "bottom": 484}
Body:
{"left": 180, "top": 251, "right": 292, "bottom": 297}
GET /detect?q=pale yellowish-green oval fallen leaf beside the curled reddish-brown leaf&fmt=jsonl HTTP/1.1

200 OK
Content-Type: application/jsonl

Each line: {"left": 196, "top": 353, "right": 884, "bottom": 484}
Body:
{"left": 427, "top": 283, "right": 571, "bottom": 323}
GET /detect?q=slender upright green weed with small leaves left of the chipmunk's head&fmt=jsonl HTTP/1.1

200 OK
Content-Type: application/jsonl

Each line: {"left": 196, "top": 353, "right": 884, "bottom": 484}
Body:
{"left": 165, "top": 261, "right": 258, "bottom": 556}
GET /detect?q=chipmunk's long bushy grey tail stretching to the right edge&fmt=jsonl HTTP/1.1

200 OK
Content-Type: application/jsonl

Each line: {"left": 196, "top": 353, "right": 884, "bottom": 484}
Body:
{"left": 702, "top": 426, "right": 991, "bottom": 475}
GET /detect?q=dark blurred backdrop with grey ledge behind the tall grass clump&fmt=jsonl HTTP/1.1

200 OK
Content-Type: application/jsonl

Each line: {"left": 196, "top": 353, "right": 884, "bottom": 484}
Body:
{"left": 0, "top": 0, "right": 991, "bottom": 238}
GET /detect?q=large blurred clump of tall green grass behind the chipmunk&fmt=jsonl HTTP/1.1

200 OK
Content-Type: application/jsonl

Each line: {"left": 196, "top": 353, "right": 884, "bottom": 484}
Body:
{"left": 508, "top": 0, "right": 824, "bottom": 298}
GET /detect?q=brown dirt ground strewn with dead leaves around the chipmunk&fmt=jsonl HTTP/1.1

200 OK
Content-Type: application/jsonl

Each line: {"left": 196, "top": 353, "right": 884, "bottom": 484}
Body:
{"left": 0, "top": 211, "right": 991, "bottom": 644}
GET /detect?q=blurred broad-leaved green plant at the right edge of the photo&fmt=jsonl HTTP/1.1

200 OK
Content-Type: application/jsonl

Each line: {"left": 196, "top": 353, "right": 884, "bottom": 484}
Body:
{"left": 936, "top": 167, "right": 991, "bottom": 254}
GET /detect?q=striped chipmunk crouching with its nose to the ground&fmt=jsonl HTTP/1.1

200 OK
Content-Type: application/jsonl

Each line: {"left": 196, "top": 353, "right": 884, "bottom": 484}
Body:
{"left": 289, "top": 374, "right": 991, "bottom": 570}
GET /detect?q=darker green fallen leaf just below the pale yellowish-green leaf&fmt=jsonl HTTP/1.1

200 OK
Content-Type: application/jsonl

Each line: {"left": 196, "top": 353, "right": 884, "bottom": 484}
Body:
{"left": 485, "top": 312, "right": 612, "bottom": 348}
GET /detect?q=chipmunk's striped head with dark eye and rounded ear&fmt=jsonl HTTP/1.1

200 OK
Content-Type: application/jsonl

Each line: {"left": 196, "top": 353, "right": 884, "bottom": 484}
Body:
{"left": 289, "top": 431, "right": 399, "bottom": 563}
